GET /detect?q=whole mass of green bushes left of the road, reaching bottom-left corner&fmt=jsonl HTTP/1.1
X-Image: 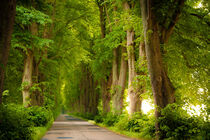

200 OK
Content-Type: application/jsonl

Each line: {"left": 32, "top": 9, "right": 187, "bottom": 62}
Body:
{"left": 0, "top": 104, "right": 53, "bottom": 140}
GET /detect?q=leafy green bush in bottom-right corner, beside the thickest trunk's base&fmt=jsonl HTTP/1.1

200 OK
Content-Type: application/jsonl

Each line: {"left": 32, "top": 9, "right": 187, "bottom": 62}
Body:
{"left": 158, "top": 104, "right": 209, "bottom": 139}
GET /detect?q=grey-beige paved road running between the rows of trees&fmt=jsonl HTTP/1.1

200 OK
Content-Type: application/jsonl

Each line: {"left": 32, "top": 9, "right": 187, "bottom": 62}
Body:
{"left": 42, "top": 114, "right": 136, "bottom": 140}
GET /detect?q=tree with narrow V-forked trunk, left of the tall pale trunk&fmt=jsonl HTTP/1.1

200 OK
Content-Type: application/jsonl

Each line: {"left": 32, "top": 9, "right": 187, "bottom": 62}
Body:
{"left": 110, "top": 3, "right": 128, "bottom": 114}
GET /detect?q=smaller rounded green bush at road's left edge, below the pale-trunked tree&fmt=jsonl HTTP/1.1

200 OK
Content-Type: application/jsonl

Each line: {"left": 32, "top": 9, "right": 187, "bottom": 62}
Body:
{"left": 27, "top": 106, "right": 53, "bottom": 127}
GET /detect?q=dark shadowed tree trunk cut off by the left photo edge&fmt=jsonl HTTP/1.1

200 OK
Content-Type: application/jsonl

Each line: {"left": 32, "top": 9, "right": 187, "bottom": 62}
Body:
{"left": 0, "top": 0, "right": 16, "bottom": 104}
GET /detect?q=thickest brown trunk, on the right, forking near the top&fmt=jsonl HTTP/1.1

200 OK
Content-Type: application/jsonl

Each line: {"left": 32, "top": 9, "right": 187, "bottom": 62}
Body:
{"left": 140, "top": 0, "right": 184, "bottom": 139}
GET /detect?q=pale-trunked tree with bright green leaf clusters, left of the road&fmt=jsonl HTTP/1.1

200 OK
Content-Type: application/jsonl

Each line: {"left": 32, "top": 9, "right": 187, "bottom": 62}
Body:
{"left": 12, "top": 5, "right": 51, "bottom": 107}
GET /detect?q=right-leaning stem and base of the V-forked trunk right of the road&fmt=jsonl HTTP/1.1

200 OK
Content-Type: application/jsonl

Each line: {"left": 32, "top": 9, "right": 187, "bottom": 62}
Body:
{"left": 112, "top": 47, "right": 128, "bottom": 114}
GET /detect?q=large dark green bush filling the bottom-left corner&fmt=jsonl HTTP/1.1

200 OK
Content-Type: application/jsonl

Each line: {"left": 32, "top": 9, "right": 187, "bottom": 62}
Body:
{"left": 0, "top": 104, "right": 33, "bottom": 140}
